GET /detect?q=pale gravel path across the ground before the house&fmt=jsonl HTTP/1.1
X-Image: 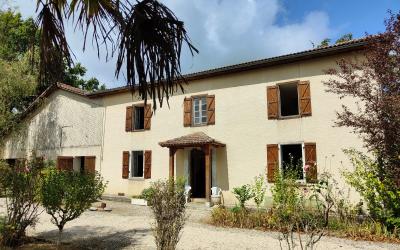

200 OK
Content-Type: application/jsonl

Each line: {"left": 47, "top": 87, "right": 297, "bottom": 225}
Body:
{"left": 0, "top": 201, "right": 400, "bottom": 250}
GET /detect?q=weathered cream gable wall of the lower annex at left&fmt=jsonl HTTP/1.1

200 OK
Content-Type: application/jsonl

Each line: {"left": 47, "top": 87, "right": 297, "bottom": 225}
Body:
{"left": 3, "top": 90, "right": 104, "bottom": 170}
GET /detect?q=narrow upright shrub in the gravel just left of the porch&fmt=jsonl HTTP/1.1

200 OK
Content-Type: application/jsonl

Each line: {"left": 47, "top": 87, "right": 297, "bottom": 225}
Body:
{"left": 149, "top": 178, "right": 186, "bottom": 249}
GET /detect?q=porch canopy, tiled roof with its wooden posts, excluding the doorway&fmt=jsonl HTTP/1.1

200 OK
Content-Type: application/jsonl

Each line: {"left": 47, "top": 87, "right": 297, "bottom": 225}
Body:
{"left": 159, "top": 132, "right": 225, "bottom": 201}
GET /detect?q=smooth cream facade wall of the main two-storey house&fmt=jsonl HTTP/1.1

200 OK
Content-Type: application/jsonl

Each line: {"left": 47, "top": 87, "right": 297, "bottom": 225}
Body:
{"left": 98, "top": 52, "right": 362, "bottom": 204}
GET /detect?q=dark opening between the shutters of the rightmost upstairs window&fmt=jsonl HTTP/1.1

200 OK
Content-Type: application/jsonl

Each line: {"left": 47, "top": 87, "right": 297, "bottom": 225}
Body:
{"left": 279, "top": 83, "right": 299, "bottom": 117}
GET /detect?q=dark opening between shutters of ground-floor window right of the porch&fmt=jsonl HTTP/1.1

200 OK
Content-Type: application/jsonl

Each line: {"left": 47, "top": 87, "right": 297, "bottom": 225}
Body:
{"left": 280, "top": 144, "right": 304, "bottom": 180}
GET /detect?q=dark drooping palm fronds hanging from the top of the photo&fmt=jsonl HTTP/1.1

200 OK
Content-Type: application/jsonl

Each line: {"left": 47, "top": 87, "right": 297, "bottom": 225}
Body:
{"left": 37, "top": 0, "right": 197, "bottom": 108}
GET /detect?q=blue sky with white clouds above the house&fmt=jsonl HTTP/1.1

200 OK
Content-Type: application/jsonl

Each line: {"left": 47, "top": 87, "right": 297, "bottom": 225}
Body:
{"left": 6, "top": 0, "right": 400, "bottom": 88}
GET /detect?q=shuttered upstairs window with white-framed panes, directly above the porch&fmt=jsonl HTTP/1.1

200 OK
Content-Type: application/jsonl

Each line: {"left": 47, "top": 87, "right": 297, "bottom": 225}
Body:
{"left": 183, "top": 95, "right": 215, "bottom": 127}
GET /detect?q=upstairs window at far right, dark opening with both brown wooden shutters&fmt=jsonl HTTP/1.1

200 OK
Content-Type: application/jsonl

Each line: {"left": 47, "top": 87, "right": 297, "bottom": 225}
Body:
{"left": 267, "top": 81, "right": 311, "bottom": 119}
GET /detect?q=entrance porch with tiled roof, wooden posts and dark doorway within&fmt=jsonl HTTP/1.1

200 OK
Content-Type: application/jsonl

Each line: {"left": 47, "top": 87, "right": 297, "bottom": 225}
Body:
{"left": 159, "top": 132, "right": 225, "bottom": 202}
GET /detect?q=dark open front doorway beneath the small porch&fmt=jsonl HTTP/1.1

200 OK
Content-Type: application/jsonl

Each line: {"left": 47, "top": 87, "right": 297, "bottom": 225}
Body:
{"left": 190, "top": 149, "right": 206, "bottom": 198}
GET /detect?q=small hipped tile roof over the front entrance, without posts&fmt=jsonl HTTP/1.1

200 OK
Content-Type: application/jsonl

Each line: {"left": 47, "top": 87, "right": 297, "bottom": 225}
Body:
{"left": 159, "top": 132, "right": 225, "bottom": 148}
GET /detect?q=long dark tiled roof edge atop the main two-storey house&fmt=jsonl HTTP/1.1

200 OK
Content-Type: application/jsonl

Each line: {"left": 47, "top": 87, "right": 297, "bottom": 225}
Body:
{"left": 87, "top": 36, "right": 376, "bottom": 98}
